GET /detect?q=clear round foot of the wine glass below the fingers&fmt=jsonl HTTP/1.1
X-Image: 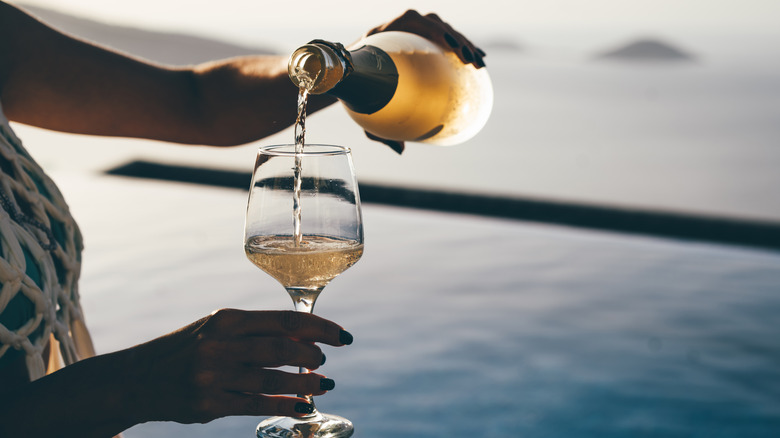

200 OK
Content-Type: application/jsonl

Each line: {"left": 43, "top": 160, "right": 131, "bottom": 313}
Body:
{"left": 257, "top": 412, "right": 354, "bottom": 438}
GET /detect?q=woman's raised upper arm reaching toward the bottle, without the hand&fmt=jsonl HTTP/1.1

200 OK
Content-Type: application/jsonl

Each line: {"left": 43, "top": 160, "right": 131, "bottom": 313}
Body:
{"left": 0, "top": 2, "right": 335, "bottom": 145}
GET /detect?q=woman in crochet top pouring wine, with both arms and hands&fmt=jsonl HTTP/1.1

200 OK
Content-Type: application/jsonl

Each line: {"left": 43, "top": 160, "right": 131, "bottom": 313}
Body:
{"left": 0, "top": 2, "right": 484, "bottom": 438}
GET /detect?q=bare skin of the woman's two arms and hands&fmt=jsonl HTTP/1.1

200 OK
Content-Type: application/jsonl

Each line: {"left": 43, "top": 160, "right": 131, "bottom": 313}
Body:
{"left": 0, "top": 1, "right": 484, "bottom": 438}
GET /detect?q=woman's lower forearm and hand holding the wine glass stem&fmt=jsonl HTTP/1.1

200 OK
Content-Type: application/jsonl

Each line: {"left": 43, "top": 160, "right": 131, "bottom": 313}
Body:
{"left": 0, "top": 310, "right": 352, "bottom": 438}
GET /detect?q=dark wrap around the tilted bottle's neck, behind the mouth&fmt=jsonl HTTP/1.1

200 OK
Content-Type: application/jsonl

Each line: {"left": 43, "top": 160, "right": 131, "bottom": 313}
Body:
{"left": 328, "top": 46, "right": 398, "bottom": 114}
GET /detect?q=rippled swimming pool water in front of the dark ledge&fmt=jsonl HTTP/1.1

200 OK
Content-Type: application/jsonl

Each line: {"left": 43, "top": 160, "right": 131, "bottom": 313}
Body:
{"left": 60, "top": 176, "right": 780, "bottom": 438}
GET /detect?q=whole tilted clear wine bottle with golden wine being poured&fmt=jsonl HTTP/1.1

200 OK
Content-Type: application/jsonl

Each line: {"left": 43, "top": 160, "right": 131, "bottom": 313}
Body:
{"left": 288, "top": 31, "right": 493, "bottom": 146}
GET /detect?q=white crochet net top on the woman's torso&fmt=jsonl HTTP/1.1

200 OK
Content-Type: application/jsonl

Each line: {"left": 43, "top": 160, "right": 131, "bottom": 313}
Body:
{"left": 0, "top": 102, "right": 94, "bottom": 380}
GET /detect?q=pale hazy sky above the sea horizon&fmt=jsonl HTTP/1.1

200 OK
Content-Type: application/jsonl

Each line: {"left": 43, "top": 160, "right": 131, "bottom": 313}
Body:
{"left": 10, "top": 0, "right": 780, "bottom": 51}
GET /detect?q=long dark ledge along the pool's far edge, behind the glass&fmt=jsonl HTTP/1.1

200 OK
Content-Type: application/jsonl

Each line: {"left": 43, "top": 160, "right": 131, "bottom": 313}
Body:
{"left": 106, "top": 161, "right": 780, "bottom": 250}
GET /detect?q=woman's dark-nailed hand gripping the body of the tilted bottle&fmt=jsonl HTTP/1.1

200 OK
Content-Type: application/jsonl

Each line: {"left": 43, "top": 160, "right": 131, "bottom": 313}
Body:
{"left": 366, "top": 9, "right": 485, "bottom": 154}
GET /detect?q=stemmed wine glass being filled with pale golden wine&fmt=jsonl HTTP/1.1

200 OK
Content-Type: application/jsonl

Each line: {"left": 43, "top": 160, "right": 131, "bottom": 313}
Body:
{"left": 244, "top": 144, "right": 363, "bottom": 438}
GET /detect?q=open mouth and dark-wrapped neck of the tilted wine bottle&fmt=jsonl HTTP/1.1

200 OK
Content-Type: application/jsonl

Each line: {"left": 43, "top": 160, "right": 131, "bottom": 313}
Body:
{"left": 288, "top": 40, "right": 398, "bottom": 114}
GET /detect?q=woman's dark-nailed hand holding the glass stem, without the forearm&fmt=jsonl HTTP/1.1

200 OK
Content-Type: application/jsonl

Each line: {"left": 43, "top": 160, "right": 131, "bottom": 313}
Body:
{"left": 128, "top": 310, "right": 352, "bottom": 423}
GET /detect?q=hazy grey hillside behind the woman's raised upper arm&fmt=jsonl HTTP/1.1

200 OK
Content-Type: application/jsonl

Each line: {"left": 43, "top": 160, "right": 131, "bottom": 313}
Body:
{"left": 19, "top": 3, "right": 274, "bottom": 65}
